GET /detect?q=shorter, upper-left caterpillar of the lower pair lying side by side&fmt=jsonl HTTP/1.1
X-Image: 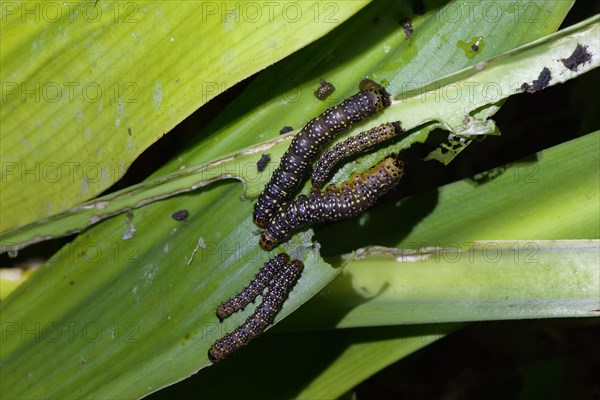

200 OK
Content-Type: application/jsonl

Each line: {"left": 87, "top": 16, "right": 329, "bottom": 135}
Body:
{"left": 217, "top": 253, "right": 290, "bottom": 322}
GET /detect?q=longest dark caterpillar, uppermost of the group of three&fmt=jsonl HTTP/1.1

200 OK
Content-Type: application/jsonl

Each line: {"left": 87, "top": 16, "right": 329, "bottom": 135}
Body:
{"left": 254, "top": 79, "right": 391, "bottom": 228}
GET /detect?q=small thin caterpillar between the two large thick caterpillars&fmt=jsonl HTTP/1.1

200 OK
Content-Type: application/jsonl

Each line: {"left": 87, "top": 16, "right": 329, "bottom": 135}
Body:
{"left": 311, "top": 122, "right": 403, "bottom": 189}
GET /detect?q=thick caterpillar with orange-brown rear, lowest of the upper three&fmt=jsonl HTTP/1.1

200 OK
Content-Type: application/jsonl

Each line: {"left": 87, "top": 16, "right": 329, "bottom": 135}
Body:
{"left": 259, "top": 154, "right": 404, "bottom": 251}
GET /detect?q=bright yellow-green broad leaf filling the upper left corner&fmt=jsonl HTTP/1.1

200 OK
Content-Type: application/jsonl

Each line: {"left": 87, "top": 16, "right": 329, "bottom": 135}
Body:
{"left": 0, "top": 0, "right": 367, "bottom": 232}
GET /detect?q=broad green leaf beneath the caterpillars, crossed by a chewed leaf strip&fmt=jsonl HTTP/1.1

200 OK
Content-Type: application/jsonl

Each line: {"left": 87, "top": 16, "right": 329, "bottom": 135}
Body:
{"left": 0, "top": 2, "right": 584, "bottom": 397}
